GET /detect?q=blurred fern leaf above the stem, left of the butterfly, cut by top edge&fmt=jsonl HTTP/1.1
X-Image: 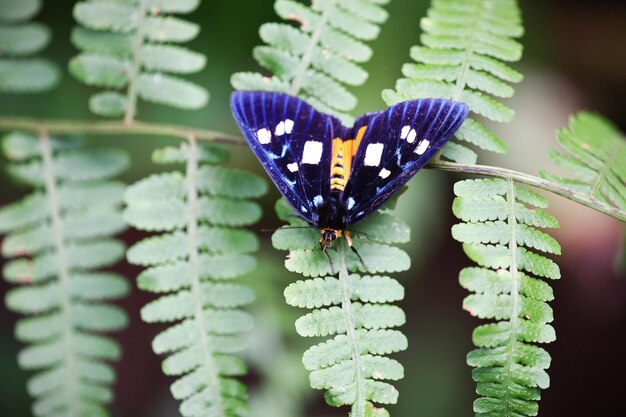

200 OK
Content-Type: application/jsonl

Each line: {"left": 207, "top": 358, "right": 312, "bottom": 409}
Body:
{"left": 69, "top": 0, "right": 209, "bottom": 121}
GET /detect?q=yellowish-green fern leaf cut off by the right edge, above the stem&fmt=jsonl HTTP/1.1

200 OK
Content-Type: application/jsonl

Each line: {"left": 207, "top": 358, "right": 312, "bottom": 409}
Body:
{"left": 541, "top": 112, "right": 626, "bottom": 210}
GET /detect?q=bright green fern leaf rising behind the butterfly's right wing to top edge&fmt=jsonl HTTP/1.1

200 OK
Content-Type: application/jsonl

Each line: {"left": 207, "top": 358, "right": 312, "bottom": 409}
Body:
{"left": 383, "top": 0, "right": 523, "bottom": 164}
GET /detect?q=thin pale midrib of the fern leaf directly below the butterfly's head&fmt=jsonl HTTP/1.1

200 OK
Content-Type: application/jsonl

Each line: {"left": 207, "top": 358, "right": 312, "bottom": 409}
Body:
{"left": 339, "top": 239, "right": 365, "bottom": 417}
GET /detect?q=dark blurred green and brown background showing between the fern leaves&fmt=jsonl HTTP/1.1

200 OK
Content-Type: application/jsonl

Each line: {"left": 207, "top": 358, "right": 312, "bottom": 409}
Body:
{"left": 0, "top": 0, "right": 626, "bottom": 417}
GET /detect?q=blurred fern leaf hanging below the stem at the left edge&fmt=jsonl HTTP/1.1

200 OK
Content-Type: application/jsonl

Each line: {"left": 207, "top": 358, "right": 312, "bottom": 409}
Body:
{"left": 0, "top": 131, "right": 129, "bottom": 416}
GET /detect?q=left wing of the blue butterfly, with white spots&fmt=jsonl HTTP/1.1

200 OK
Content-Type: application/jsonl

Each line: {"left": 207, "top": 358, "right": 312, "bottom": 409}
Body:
{"left": 230, "top": 91, "right": 341, "bottom": 224}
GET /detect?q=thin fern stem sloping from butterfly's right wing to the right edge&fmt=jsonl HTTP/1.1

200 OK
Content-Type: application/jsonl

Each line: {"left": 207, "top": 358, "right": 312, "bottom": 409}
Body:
{"left": 427, "top": 161, "right": 626, "bottom": 222}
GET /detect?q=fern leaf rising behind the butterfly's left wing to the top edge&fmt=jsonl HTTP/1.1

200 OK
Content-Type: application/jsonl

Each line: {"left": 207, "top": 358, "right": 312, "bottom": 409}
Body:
{"left": 231, "top": 0, "right": 387, "bottom": 125}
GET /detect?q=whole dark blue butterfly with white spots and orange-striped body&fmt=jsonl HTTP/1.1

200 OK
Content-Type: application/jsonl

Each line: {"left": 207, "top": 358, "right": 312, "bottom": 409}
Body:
{"left": 231, "top": 91, "right": 468, "bottom": 252}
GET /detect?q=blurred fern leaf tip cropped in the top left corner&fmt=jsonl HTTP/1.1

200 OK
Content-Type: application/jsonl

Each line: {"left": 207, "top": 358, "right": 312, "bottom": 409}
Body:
{"left": 0, "top": 0, "right": 60, "bottom": 93}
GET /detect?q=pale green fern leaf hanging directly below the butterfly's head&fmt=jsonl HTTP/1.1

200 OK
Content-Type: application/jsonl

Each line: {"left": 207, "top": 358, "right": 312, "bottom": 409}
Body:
{"left": 272, "top": 200, "right": 410, "bottom": 416}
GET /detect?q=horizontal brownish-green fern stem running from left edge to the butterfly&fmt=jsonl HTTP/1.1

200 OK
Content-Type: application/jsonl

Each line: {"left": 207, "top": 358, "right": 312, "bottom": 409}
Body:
{"left": 0, "top": 117, "right": 246, "bottom": 145}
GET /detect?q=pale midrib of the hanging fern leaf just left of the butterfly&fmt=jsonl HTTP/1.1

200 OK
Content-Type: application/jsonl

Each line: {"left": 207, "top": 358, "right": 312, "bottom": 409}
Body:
{"left": 186, "top": 135, "right": 226, "bottom": 417}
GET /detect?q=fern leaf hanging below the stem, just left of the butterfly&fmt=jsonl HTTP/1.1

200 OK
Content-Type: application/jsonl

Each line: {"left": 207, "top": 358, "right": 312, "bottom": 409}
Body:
{"left": 125, "top": 141, "right": 267, "bottom": 417}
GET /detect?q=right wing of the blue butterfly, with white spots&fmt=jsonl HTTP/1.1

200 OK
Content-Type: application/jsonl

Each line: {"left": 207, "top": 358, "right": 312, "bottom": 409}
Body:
{"left": 342, "top": 99, "right": 468, "bottom": 225}
